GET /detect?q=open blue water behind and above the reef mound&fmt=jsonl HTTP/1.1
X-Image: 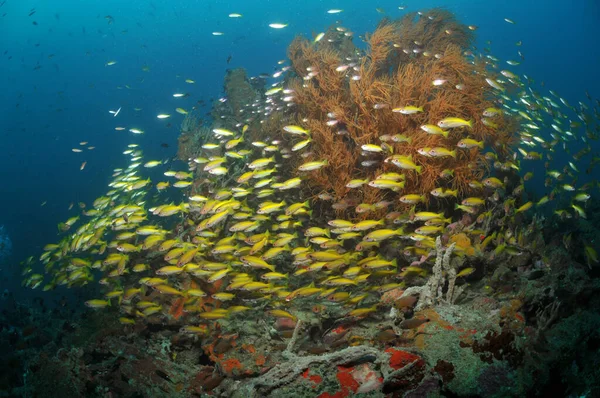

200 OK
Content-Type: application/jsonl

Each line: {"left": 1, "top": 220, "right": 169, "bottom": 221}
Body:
{"left": 0, "top": 0, "right": 600, "bottom": 298}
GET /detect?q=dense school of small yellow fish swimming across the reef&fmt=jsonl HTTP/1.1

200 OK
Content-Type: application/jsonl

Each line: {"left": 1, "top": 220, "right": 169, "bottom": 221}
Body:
{"left": 24, "top": 10, "right": 599, "bottom": 334}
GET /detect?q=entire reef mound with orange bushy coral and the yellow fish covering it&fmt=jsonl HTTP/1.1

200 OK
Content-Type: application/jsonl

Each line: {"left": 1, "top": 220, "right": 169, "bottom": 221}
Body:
{"left": 16, "top": 9, "right": 600, "bottom": 398}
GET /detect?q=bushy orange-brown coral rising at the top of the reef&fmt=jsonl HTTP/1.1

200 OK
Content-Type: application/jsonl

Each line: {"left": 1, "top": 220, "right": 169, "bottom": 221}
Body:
{"left": 288, "top": 10, "right": 514, "bottom": 221}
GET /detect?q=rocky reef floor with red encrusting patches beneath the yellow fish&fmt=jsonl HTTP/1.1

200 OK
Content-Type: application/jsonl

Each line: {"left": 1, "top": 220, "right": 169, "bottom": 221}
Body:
{"left": 7, "top": 241, "right": 600, "bottom": 398}
